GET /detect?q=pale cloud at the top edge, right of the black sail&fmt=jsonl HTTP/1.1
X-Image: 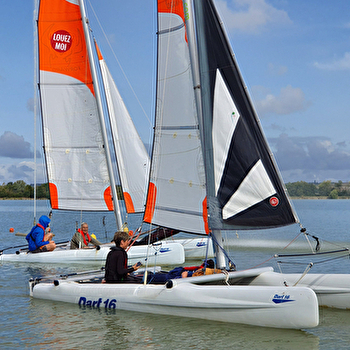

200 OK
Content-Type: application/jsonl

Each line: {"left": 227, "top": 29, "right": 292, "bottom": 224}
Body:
{"left": 216, "top": 0, "right": 292, "bottom": 34}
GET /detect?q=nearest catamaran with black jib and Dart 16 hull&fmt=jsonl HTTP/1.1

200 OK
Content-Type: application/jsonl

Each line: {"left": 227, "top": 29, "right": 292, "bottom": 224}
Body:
{"left": 29, "top": 0, "right": 319, "bottom": 329}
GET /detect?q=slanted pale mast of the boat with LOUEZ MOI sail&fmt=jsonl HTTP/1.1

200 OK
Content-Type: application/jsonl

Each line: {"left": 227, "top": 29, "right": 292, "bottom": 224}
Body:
{"left": 80, "top": 0, "right": 123, "bottom": 229}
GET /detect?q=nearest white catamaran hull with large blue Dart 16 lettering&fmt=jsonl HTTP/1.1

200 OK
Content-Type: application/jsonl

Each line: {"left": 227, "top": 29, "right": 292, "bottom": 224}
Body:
{"left": 30, "top": 272, "right": 319, "bottom": 329}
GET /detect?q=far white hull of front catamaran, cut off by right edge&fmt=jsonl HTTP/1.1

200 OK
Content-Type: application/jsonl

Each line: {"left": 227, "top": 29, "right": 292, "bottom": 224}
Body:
{"left": 251, "top": 272, "right": 350, "bottom": 309}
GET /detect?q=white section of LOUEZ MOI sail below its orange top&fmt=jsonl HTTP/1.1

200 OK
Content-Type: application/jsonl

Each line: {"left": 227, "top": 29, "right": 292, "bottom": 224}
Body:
{"left": 40, "top": 71, "right": 109, "bottom": 211}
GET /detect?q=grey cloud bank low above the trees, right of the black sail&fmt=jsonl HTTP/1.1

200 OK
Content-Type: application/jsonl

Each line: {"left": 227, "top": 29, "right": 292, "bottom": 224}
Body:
{"left": 269, "top": 134, "right": 350, "bottom": 182}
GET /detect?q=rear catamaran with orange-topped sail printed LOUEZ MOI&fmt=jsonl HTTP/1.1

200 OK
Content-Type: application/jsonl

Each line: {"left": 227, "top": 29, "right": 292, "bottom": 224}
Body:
{"left": 0, "top": 0, "right": 189, "bottom": 265}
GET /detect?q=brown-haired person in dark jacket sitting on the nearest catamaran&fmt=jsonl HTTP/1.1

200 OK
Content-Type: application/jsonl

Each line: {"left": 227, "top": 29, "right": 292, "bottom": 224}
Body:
{"left": 105, "top": 231, "right": 142, "bottom": 283}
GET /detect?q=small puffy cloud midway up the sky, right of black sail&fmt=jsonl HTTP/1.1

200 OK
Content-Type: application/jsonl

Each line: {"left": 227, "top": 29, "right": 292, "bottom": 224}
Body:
{"left": 255, "top": 85, "right": 311, "bottom": 116}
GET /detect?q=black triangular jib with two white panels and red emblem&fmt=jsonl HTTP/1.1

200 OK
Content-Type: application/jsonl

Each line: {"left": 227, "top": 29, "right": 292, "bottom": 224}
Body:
{"left": 194, "top": 0, "right": 298, "bottom": 229}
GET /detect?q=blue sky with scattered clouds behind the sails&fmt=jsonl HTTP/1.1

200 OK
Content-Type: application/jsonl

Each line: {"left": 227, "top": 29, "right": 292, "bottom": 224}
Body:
{"left": 0, "top": 0, "right": 350, "bottom": 184}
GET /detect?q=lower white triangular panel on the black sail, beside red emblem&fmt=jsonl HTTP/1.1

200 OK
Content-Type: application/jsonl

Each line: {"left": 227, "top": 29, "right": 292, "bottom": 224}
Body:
{"left": 222, "top": 160, "right": 276, "bottom": 220}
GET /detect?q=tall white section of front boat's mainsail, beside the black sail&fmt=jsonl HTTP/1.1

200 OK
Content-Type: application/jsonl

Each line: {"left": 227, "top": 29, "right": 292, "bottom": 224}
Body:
{"left": 150, "top": 13, "right": 206, "bottom": 233}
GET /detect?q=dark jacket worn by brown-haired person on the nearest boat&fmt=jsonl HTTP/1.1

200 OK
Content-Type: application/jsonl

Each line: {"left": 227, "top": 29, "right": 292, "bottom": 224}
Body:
{"left": 105, "top": 247, "right": 134, "bottom": 283}
